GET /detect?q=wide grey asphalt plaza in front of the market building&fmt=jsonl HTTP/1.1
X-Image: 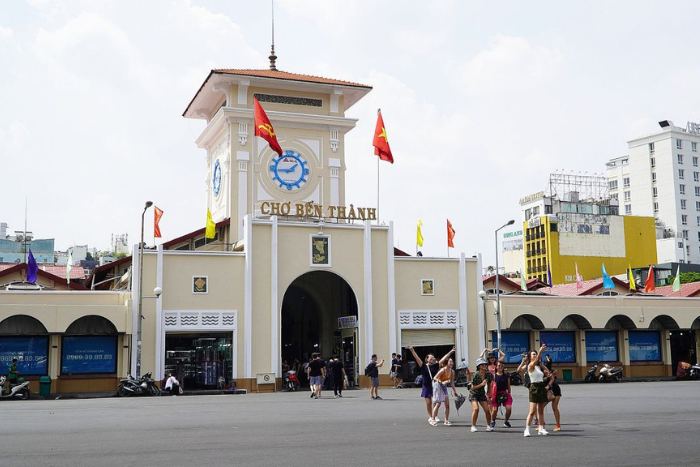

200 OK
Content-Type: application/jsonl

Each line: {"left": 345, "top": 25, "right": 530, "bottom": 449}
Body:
{"left": 0, "top": 381, "right": 700, "bottom": 467}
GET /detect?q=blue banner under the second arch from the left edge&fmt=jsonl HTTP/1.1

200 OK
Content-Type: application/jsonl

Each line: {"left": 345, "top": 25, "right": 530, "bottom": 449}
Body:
{"left": 61, "top": 336, "right": 117, "bottom": 375}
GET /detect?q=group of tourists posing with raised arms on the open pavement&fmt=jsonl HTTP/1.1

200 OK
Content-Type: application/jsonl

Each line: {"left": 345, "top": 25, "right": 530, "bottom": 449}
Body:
{"left": 408, "top": 343, "right": 561, "bottom": 437}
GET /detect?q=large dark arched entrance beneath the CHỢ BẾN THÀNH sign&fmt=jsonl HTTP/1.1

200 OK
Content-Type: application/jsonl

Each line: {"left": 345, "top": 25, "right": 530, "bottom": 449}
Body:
{"left": 281, "top": 271, "right": 358, "bottom": 384}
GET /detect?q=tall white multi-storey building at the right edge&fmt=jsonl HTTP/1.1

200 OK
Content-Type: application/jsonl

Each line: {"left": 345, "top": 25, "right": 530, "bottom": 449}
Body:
{"left": 606, "top": 120, "right": 700, "bottom": 264}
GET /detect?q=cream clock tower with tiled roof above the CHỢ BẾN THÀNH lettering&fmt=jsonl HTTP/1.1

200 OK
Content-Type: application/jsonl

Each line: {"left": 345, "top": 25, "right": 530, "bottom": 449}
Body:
{"left": 183, "top": 69, "right": 372, "bottom": 242}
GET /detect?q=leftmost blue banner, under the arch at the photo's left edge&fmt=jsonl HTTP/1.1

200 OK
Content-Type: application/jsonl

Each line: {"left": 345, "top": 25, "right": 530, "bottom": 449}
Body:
{"left": 0, "top": 337, "right": 49, "bottom": 377}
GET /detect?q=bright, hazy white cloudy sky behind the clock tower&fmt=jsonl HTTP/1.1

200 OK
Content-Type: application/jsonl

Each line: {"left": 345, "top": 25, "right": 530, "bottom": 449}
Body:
{"left": 0, "top": 0, "right": 700, "bottom": 265}
